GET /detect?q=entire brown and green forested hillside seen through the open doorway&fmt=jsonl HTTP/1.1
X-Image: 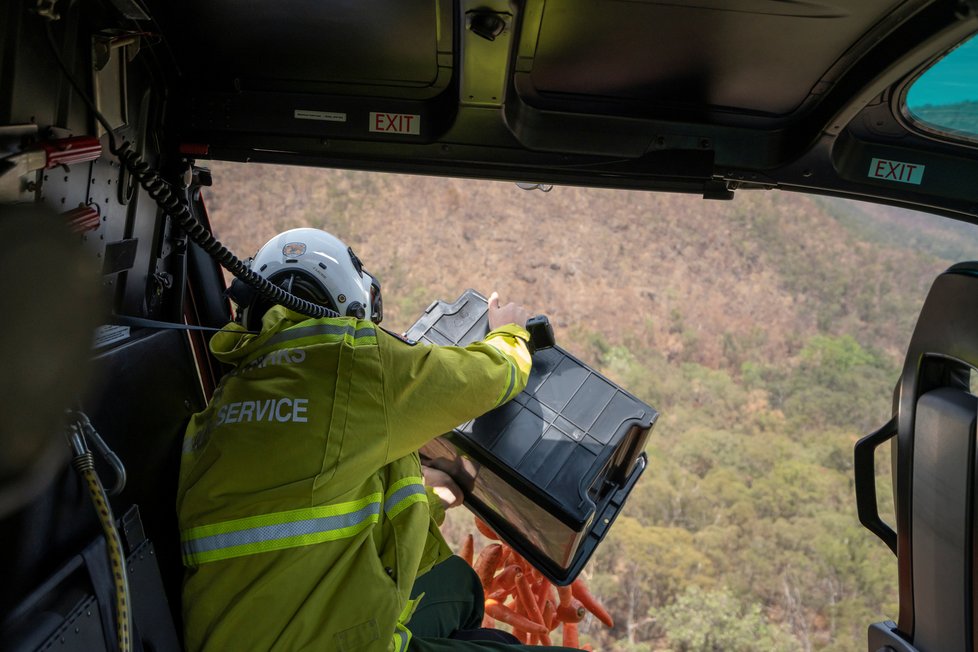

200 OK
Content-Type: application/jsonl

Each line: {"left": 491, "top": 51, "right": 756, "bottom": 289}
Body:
{"left": 207, "top": 163, "right": 978, "bottom": 652}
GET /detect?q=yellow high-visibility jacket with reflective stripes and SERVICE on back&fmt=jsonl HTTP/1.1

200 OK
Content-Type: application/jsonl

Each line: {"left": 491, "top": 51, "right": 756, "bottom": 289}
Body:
{"left": 177, "top": 306, "right": 530, "bottom": 652}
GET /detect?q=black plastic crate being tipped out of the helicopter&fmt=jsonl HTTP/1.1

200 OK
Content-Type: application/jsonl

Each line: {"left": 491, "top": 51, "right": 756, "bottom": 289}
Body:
{"left": 406, "top": 290, "right": 658, "bottom": 584}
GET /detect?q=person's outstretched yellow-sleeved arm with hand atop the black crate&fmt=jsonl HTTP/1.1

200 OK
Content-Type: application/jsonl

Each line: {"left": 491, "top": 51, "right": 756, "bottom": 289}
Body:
{"left": 378, "top": 292, "right": 531, "bottom": 461}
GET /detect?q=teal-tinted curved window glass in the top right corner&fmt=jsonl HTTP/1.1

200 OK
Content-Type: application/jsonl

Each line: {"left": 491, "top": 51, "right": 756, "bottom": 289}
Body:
{"left": 906, "top": 35, "right": 978, "bottom": 142}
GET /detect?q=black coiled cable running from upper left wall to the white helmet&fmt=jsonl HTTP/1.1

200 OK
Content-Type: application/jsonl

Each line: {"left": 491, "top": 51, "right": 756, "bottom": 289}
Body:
{"left": 45, "top": 20, "right": 340, "bottom": 319}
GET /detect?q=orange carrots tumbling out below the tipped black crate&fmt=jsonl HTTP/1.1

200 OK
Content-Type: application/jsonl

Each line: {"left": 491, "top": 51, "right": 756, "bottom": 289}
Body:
{"left": 459, "top": 518, "right": 615, "bottom": 650}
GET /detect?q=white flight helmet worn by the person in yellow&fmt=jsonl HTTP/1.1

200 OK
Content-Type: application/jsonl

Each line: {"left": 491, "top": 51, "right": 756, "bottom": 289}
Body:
{"left": 242, "top": 229, "right": 384, "bottom": 330}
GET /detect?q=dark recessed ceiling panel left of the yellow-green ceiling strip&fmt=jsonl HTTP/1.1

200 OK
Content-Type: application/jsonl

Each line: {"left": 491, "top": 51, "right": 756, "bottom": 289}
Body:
{"left": 157, "top": 0, "right": 452, "bottom": 90}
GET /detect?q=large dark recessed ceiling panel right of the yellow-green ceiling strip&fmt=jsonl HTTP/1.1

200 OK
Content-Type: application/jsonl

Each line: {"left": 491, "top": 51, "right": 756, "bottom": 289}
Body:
{"left": 521, "top": 0, "right": 903, "bottom": 115}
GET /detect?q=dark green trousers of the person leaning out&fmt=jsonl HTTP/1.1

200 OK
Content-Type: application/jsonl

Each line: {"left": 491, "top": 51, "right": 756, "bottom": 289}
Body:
{"left": 408, "top": 556, "right": 573, "bottom": 652}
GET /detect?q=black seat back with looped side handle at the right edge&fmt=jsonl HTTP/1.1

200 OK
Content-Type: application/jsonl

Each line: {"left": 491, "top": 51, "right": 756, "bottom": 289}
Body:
{"left": 855, "top": 262, "right": 978, "bottom": 652}
